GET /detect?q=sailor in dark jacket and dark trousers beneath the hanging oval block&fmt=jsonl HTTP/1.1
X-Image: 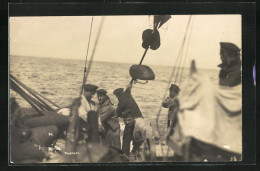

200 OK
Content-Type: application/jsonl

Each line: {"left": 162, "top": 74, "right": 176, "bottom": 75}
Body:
{"left": 113, "top": 83, "right": 143, "bottom": 156}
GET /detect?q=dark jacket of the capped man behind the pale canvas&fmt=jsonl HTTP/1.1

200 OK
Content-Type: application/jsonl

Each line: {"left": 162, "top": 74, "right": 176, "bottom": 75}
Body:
{"left": 218, "top": 60, "right": 241, "bottom": 87}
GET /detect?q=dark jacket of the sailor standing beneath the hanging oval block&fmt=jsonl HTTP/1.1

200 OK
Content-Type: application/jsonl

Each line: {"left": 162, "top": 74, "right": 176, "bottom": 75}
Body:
{"left": 116, "top": 87, "right": 143, "bottom": 119}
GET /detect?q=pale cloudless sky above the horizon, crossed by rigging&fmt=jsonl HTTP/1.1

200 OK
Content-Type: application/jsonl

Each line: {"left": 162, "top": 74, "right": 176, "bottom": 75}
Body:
{"left": 9, "top": 15, "right": 242, "bottom": 69}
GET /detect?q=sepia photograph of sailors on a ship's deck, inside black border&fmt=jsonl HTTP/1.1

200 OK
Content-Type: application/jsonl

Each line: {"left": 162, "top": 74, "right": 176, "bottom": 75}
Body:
{"left": 9, "top": 14, "right": 243, "bottom": 164}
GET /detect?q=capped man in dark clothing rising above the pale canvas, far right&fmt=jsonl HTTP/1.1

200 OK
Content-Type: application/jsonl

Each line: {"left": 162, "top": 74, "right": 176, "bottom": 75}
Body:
{"left": 218, "top": 42, "right": 241, "bottom": 87}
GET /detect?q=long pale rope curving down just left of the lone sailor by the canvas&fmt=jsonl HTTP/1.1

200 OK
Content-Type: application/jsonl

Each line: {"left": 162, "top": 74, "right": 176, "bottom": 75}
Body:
{"left": 156, "top": 16, "right": 191, "bottom": 161}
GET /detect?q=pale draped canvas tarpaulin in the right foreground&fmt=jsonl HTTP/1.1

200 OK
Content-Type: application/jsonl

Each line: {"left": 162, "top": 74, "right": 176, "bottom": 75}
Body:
{"left": 168, "top": 73, "right": 242, "bottom": 159}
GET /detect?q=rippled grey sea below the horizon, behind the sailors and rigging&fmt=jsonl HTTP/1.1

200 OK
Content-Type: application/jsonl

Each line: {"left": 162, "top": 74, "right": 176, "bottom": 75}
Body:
{"left": 9, "top": 56, "right": 219, "bottom": 134}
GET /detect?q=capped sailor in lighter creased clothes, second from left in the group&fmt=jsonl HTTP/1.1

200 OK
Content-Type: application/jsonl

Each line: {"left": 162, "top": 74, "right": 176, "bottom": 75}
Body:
{"left": 97, "top": 89, "right": 121, "bottom": 149}
